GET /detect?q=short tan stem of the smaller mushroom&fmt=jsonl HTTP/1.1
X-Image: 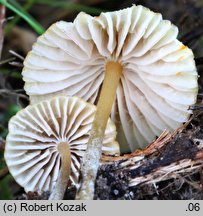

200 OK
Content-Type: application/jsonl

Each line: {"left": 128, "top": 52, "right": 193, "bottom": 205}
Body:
{"left": 49, "top": 142, "right": 71, "bottom": 200}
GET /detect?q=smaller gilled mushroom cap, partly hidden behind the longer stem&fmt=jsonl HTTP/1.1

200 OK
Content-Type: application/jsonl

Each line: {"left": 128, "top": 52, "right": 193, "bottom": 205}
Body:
{"left": 5, "top": 96, "right": 119, "bottom": 192}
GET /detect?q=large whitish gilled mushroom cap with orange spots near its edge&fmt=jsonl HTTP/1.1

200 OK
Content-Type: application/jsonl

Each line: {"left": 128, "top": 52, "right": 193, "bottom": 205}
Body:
{"left": 23, "top": 5, "right": 197, "bottom": 151}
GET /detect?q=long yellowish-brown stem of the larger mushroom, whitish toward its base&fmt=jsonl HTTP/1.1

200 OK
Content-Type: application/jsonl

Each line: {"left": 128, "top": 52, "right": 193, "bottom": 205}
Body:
{"left": 76, "top": 61, "right": 123, "bottom": 200}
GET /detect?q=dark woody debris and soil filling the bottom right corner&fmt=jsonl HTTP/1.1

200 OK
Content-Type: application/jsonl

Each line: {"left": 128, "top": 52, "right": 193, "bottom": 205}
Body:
{"left": 92, "top": 111, "right": 203, "bottom": 199}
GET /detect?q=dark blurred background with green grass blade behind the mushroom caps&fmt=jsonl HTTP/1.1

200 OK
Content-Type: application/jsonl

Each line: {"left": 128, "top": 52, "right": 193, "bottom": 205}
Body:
{"left": 0, "top": 0, "right": 203, "bottom": 199}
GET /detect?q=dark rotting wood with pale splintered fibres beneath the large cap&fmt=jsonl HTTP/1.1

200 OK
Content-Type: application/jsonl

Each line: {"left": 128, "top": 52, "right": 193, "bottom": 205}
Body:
{"left": 94, "top": 112, "right": 203, "bottom": 199}
